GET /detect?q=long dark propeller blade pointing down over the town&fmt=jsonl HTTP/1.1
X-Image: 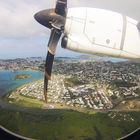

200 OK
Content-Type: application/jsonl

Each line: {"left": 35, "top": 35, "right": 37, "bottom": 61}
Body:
{"left": 44, "top": 29, "right": 61, "bottom": 102}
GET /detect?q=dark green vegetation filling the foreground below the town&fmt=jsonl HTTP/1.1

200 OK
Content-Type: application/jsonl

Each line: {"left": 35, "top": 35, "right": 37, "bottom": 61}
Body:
{"left": 0, "top": 104, "right": 140, "bottom": 140}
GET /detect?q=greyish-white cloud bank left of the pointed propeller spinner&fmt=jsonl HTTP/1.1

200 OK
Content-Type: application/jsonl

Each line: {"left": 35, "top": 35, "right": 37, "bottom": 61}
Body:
{"left": 0, "top": 0, "right": 52, "bottom": 38}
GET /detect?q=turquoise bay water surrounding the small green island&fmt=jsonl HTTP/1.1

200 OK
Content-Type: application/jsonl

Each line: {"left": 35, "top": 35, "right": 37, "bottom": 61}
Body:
{"left": 0, "top": 71, "right": 43, "bottom": 97}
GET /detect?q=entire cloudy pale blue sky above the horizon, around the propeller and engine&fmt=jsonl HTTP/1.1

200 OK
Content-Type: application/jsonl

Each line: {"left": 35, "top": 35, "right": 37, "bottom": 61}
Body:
{"left": 0, "top": 0, "right": 140, "bottom": 59}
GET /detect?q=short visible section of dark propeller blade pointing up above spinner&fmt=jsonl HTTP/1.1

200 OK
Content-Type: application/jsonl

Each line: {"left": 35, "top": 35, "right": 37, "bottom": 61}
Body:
{"left": 55, "top": 0, "right": 67, "bottom": 17}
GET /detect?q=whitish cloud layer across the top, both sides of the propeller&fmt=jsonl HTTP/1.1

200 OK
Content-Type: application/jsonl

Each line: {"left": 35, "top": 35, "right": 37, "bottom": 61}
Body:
{"left": 0, "top": 0, "right": 140, "bottom": 38}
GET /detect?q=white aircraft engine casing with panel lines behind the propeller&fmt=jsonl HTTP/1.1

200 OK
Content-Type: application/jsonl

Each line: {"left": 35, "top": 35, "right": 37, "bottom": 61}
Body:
{"left": 63, "top": 7, "right": 140, "bottom": 59}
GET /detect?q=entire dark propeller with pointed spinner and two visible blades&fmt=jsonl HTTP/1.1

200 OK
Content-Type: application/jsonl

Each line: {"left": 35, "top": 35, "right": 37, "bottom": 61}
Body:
{"left": 34, "top": 0, "right": 67, "bottom": 102}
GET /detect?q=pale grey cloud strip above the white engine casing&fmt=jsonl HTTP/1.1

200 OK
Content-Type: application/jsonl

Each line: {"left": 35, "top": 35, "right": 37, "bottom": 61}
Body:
{"left": 69, "top": 0, "right": 140, "bottom": 21}
